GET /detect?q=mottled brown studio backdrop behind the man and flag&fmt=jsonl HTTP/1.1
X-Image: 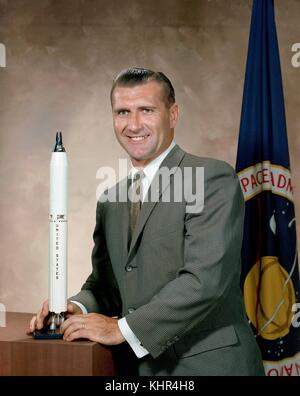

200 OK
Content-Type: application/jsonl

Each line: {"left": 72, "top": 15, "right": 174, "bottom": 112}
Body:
{"left": 0, "top": 0, "right": 300, "bottom": 312}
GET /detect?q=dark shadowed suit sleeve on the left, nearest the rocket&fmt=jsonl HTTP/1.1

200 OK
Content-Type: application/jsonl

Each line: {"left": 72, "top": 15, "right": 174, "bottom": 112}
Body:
{"left": 71, "top": 202, "right": 121, "bottom": 316}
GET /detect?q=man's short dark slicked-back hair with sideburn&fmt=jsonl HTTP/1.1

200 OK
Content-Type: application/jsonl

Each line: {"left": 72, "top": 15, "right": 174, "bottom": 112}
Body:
{"left": 110, "top": 67, "right": 175, "bottom": 107}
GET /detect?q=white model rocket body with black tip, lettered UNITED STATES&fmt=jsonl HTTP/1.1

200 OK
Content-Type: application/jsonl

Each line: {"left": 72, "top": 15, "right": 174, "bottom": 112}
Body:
{"left": 49, "top": 133, "right": 68, "bottom": 314}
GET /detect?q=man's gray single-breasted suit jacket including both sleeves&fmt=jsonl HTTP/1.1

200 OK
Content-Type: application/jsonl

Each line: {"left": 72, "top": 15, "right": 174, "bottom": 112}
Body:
{"left": 72, "top": 146, "right": 263, "bottom": 375}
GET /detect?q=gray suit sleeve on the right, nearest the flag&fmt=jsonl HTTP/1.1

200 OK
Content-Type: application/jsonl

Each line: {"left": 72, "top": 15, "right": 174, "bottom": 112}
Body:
{"left": 126, "top": 161, "right": 244, "bottom": 358}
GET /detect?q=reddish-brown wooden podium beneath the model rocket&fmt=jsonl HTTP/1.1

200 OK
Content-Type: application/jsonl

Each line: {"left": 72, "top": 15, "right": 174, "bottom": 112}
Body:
{"left": 0, "top": 312, "right": 115, "bottom": 376}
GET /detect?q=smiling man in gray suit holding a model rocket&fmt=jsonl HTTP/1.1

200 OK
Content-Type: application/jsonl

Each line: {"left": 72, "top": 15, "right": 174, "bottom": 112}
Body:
{"left": 30, "top": 68, "right": 263, "bottom": 375}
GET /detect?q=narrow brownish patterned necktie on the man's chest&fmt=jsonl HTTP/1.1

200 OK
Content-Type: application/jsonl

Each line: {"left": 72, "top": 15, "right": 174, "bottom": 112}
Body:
{"left": 130, "top": 171, "right": 145, "bottom": 241}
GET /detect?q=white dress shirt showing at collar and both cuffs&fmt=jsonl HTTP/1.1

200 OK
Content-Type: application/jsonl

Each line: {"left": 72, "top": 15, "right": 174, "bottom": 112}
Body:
{"left": 72, "top": 140, "right": 175, "bottom": 358}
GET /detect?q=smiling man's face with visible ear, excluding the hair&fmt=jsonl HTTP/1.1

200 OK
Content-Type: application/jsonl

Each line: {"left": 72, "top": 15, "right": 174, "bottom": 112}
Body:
{"left": 112, "top": 81, "right": 178, "bottom": 167}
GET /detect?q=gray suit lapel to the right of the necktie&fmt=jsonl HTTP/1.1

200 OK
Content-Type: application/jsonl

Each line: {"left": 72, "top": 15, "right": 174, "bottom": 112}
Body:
{"left": 127, "top": 145, "right": 185, "bottom": 261}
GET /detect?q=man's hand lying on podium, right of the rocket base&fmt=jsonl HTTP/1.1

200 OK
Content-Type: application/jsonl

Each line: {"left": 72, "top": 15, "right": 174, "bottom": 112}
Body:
{"left": 61, "top": 313, "right": 125, "bottom": 345}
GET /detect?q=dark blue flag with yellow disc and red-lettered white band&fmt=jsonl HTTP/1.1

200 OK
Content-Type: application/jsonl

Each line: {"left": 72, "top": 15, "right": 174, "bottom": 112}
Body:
{"left": 236, "top": 0, "right": 300, "bottom": 376}
